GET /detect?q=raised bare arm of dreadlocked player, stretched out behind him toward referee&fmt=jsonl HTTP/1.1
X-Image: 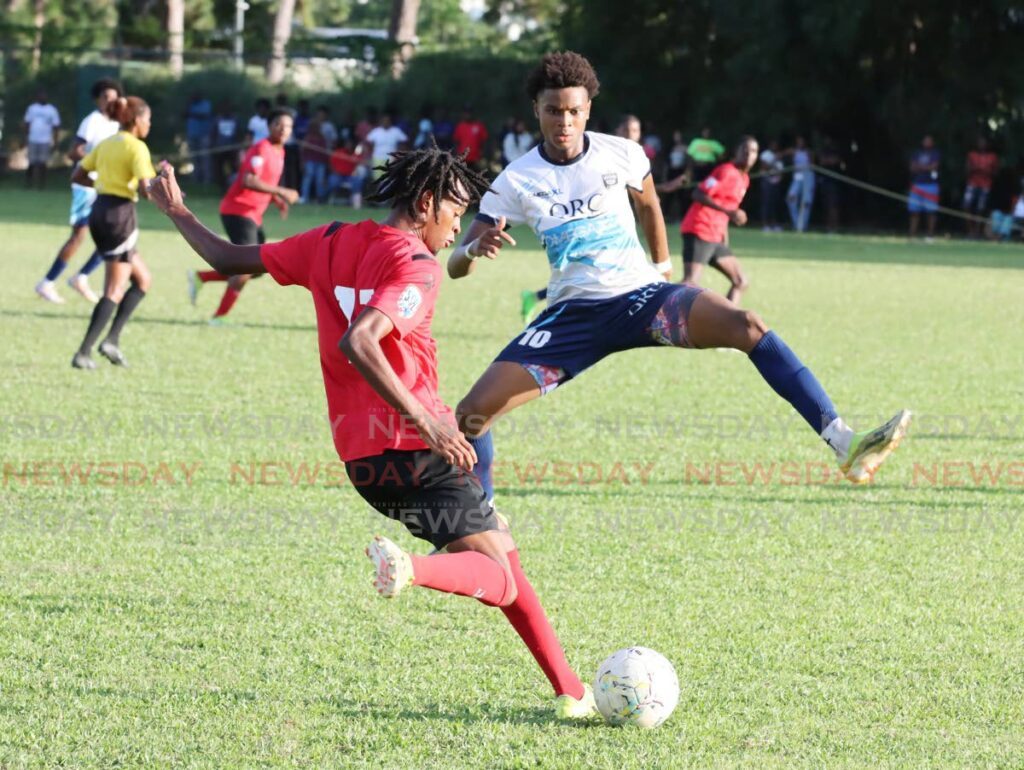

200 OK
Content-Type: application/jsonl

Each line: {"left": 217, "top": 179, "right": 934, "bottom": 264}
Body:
{"left": 150, "top": 162, "right": 266, "bottom": 275}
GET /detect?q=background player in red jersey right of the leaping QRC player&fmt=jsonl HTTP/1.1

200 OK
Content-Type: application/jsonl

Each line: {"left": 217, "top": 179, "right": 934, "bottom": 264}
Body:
{"left": 679, "top": 136, "right": 758, "bottom": 305}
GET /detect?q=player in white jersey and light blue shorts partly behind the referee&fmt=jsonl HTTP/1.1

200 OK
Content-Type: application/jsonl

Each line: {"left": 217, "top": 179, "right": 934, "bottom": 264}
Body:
{"left": 36, "top": 78, "right": 122, "bottom": 304}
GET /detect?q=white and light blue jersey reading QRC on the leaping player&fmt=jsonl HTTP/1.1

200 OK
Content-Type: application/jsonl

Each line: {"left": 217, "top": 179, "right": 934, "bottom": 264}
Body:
{"left": 480, "top": 131, "right": 664, "bottom": 305}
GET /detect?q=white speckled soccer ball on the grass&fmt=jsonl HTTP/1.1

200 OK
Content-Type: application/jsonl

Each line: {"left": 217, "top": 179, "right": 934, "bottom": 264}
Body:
{"left": 594, "top": 647, "right": 679, "bottom": 729}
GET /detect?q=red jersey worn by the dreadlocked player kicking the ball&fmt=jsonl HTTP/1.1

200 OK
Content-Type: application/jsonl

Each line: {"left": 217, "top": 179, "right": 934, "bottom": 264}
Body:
{"left": 260, "top": 219, "right": 448, "bottom": 462}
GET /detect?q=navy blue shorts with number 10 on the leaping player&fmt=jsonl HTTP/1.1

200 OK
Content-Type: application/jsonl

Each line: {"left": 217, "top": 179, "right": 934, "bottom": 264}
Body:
{"left": 495, "top": 283, "right": 703, "bottom": 393}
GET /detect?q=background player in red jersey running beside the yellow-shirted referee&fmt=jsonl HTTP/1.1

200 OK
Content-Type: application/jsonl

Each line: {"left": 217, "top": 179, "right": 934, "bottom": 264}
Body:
{"left": 187, "top": 110, "right": 299, "bottom": 323}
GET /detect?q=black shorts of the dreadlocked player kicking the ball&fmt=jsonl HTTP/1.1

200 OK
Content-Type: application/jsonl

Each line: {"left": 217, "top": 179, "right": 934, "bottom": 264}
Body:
{"left": 345, "top": 450, "right": 499, "bottom": 549}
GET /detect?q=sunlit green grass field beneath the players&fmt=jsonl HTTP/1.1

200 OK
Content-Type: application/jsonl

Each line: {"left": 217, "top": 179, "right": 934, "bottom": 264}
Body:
{"left": 0, "top": 183, "right": 1024, "bottom": 768}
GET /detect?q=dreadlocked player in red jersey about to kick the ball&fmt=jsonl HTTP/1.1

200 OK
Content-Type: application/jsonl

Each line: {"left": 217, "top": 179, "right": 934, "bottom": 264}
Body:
{"left": 153, "top": 147, "right": 596, "bottom": 719}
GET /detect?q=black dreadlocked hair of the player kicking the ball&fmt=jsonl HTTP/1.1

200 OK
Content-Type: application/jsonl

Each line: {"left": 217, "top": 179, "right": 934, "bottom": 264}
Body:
{"left": 367, "top": 143, "right": 490, "bottom": 222}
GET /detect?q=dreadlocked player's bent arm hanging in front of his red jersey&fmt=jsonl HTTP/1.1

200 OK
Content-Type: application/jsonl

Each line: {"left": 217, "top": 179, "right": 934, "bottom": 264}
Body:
{"left": 338, "top": 307, "right": 476, "bottom": 471}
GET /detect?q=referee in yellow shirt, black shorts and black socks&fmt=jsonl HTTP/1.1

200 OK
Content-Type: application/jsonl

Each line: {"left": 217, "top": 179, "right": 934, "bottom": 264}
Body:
{"left": 71, "top": 96, "right": 157, "bottom": 369}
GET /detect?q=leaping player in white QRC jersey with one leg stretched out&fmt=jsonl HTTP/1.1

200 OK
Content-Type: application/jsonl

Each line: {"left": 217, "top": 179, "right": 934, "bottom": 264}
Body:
{"left": 447, "top": 52, "right": 910, "bottom": 494}
